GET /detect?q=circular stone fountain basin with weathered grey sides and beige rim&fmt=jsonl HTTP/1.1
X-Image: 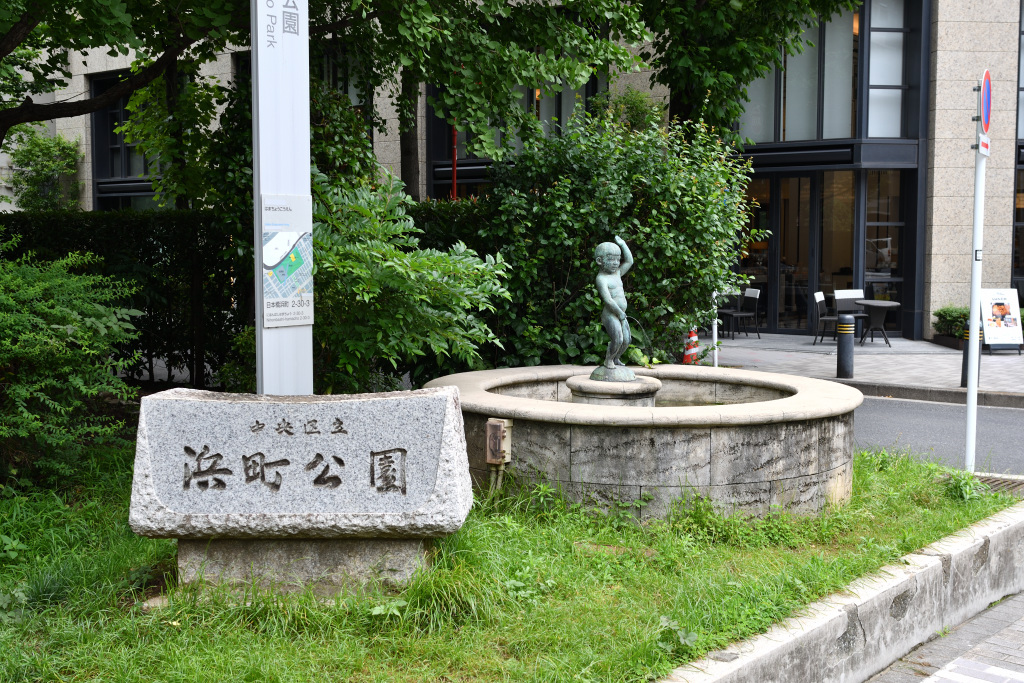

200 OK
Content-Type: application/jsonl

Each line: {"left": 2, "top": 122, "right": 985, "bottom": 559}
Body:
{"left": 427, "top": 366, "right": 863, "bottom": 518}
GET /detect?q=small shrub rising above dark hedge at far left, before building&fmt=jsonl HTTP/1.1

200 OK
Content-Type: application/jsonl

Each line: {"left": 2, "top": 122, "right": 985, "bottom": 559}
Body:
{"left": 3, "top": 128, "right": 82, "bottom": 211}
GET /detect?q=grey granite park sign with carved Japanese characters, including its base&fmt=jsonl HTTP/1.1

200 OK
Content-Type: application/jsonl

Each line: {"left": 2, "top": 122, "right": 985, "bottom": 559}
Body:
{"left": 130, "top": 387, "right": 473, "bottom": 587}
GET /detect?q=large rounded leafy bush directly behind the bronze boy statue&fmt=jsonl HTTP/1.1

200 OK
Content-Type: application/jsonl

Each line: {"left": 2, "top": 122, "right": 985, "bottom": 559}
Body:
{"left": 419, "top": 96, "right": 760, "bottom": 367}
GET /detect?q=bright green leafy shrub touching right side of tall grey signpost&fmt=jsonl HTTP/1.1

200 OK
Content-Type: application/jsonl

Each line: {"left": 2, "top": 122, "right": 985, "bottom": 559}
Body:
{"left": 313, "top": 173, "right": 507, "bottom": 393}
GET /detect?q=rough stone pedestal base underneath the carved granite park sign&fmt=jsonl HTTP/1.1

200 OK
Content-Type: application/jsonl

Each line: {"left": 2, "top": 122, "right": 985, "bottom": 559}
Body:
{"left": 178, "top": 539, "right": 432, "bottom": 595}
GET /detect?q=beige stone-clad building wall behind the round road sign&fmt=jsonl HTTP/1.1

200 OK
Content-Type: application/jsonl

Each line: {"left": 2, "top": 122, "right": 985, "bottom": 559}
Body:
{"left": 925, "top": 0, "right": 1021, "bottom": 337}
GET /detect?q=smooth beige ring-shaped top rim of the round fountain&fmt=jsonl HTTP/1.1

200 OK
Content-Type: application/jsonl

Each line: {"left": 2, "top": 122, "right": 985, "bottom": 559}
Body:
{"left": 425, "top": 365, "right": 864, "bottom": 427}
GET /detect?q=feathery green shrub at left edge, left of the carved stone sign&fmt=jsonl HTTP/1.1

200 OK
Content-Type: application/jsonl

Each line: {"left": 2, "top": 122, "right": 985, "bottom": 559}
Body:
{"left": 0, "top": 237, "right": 141, "bottom": 478}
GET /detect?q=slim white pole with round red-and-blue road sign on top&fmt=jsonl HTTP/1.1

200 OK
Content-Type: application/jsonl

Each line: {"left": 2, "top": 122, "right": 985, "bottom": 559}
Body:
{"left": 964, "top": 69, "right": 992, "bottom": 472}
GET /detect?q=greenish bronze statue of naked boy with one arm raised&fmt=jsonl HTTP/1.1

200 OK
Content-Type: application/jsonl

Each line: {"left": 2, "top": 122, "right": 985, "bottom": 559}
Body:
{"left": 591, "top": 236, "right": 635, "bottom": 382}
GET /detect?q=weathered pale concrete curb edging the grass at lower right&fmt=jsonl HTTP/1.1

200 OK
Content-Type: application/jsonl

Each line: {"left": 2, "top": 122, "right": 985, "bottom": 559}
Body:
{"left": 663, "top": 503, "right": 1024, "bottom": 683}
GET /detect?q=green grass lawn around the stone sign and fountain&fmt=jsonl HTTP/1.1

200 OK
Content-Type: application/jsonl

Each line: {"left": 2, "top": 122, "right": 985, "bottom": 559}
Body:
{"left": 0, "top": 453, "right": 1013, "bottom": 682}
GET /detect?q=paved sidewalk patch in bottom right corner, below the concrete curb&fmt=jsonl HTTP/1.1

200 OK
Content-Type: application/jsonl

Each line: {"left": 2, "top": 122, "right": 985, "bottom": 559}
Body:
{"left": 868, "top": 593, "right": 1024, "bottom": 683}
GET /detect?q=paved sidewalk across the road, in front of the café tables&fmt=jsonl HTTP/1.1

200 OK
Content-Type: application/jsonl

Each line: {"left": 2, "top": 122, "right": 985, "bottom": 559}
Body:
{"left": 700, "top": 333, "right": 1024, "bottom": 408}
